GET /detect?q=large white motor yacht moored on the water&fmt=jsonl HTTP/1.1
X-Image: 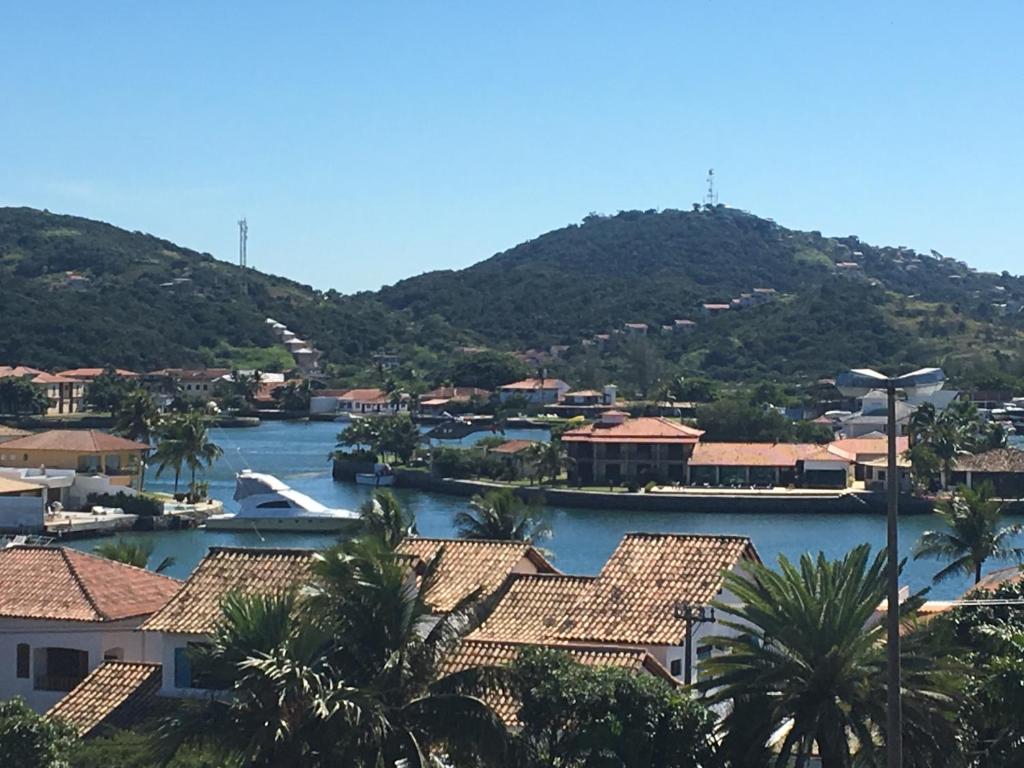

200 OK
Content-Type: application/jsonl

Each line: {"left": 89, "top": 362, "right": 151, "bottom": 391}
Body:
{"left": 206, "top": 469, "right": 360, "bottom": 532}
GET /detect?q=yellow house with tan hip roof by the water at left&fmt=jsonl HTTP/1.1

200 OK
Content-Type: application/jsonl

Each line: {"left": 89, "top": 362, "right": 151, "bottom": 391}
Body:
{"left": 0, "top": 429, "right": 150, "bottom": 485}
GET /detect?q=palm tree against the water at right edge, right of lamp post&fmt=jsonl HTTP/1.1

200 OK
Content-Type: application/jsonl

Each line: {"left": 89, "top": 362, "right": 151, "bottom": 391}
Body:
{"left": 913, "top": 481, "right": 1024, "bottom": 584}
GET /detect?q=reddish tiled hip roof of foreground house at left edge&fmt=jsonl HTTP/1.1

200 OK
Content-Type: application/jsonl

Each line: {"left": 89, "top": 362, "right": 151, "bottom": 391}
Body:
{"left": 0, "top": 546, "right": 181, "bottom": 622}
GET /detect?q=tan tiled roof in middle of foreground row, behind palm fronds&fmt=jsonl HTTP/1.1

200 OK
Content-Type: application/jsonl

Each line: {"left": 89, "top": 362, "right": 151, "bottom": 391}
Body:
{"left": 397, "top": 538, "right": 558, "bottom": 613}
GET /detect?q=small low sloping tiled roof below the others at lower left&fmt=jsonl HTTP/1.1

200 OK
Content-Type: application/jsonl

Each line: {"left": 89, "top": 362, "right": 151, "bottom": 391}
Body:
{"left": 46, "top": 662, "right": 163, "bottom": 738}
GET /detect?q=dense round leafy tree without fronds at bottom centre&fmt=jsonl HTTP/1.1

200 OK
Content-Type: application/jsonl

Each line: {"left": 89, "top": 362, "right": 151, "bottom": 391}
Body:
{"left": 508, "top": 647, "right": 714, "bottom": 768}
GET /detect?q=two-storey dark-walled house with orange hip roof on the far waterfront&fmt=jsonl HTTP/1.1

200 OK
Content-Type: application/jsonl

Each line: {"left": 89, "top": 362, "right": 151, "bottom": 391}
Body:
{"left": 562, "top": 411, "right": 703, "bottom": 485}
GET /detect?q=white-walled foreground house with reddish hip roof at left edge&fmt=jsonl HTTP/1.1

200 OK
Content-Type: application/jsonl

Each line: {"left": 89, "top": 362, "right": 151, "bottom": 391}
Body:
{"left": 0, "top": 545, "right": 179, "bottom": 712}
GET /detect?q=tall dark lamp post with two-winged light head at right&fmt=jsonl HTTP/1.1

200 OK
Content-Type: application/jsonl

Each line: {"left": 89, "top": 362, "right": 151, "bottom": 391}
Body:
{"left": 836, "top": 368, "right": 946, "bottom": 768}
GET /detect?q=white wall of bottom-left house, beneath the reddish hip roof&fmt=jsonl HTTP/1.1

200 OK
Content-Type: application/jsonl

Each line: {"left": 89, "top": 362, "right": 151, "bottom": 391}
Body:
{"left": 0, "top": 618, "right": 143, "bottom": 713}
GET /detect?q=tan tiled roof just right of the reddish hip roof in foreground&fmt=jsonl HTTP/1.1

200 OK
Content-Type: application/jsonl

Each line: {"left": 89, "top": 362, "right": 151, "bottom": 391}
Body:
{"left": 139, "top": 547, "right": 315, "bottom": 635}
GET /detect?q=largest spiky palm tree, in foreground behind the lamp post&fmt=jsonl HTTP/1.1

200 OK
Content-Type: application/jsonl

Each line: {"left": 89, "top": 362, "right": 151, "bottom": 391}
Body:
{"left": 700, "top": 545, "right": 955, "bottom": 768}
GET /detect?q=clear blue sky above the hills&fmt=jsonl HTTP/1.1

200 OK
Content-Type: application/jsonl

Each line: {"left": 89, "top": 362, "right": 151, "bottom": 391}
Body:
{"left": 0, "top": 0, "right": 1024, "bottom": 292}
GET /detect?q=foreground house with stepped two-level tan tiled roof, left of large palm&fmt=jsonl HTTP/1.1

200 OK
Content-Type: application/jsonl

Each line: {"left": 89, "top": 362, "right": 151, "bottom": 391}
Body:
{"left": 467, "top": 534, "right": 760, "bottom": 680}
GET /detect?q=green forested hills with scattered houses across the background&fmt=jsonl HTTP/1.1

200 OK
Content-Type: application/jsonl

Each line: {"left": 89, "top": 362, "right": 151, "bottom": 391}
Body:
{"left": 0, "top": 207, "right": 1024, "bottom": 390}
